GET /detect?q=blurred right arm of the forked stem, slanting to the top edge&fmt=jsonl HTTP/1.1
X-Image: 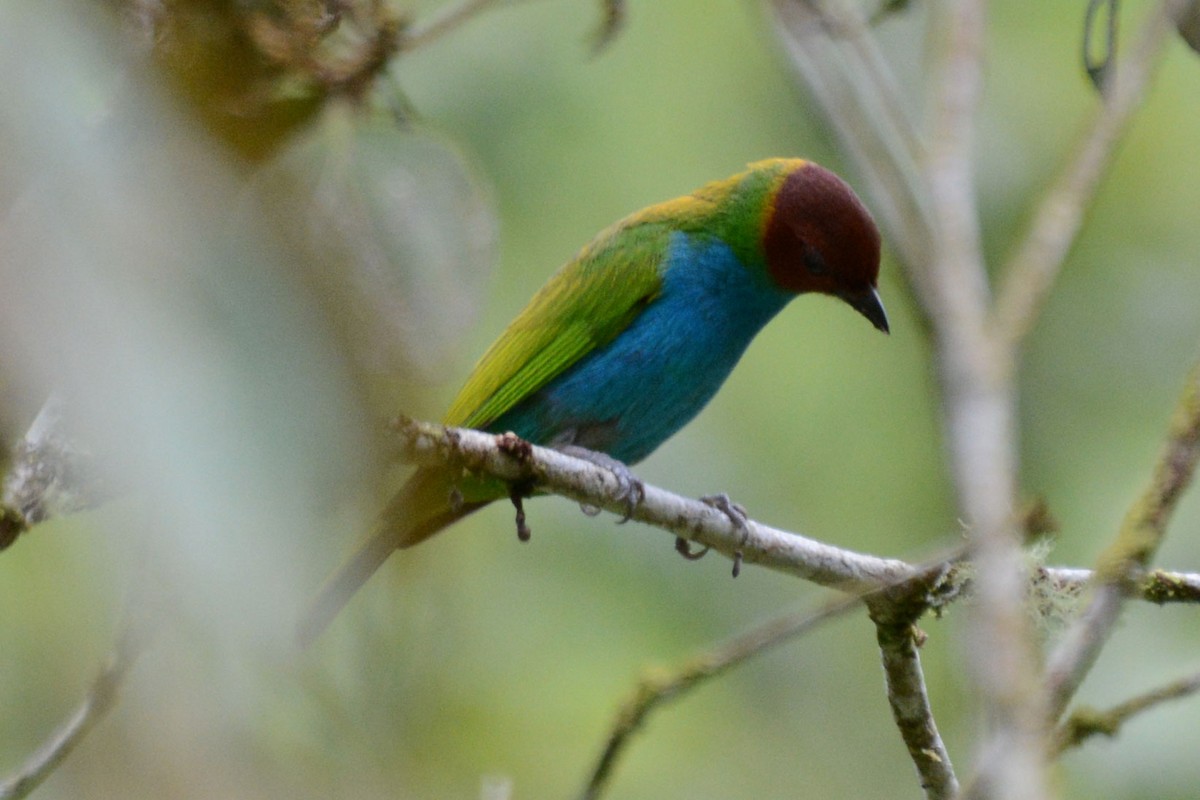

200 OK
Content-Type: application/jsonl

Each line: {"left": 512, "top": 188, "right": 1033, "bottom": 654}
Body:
{"left": 992, "top": 2, "right": 1180, "bottom": 360}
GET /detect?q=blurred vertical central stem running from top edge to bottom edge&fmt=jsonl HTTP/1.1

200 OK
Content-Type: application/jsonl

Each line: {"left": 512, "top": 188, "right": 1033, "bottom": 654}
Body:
{"left": 918, "top": 0, "right": 1048, "bottom": 800}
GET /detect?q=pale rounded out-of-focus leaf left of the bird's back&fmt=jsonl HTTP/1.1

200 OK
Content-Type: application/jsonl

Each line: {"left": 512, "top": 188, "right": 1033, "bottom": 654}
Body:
{"left": 254, "top": 104, "right": 497, "bottom": 377}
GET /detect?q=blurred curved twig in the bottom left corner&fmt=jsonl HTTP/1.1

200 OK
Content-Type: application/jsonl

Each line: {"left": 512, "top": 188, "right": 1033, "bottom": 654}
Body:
{"left": 0, "top": 603, "right": 149, "bottom": 800}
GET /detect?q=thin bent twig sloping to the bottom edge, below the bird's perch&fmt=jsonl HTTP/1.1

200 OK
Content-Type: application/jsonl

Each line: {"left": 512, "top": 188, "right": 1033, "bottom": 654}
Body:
{"left": 580, "top": 587, "right": 862, "bottom": 800}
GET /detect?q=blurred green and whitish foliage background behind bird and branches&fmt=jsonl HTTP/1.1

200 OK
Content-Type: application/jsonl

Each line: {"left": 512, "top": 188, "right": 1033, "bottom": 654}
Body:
{"left": 0, "top": 0, "right": 1200, "bottom": 799}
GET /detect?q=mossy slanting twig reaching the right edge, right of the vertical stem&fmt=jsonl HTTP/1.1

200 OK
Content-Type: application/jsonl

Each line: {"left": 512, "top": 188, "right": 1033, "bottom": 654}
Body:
{"left": 1045, "top": 362, "right": 1200, "bottom": 720}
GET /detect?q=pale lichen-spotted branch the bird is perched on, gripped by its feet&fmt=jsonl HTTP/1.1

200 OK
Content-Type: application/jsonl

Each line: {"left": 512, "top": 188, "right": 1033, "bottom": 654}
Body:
{"left": 391, "top": 419, "right": 913, "bottom": 591}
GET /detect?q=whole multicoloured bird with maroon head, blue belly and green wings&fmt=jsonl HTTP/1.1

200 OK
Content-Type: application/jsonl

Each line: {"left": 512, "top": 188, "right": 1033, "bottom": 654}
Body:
{"left": 300, "top": 158, "right": 888, "bottom": 644}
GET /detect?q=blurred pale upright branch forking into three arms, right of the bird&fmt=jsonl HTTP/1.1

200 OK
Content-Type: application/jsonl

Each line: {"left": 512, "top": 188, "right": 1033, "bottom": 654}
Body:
{"left": 770, "top": 0, "right": 1182, "bottom": 799}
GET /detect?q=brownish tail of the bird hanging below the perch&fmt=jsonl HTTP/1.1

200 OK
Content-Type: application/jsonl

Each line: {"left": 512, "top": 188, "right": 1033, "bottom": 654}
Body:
{"left": 296, "top": 469, "right": 488, "bottom": 648}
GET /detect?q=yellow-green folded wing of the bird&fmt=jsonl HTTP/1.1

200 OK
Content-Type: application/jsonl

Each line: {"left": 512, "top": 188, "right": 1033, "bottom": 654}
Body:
{"left": 445, "top": 215, "right": 671, "bottom": 428}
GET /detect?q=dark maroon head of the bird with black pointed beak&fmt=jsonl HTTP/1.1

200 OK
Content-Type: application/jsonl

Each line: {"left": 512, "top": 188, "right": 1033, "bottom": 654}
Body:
{"left": 762, "top": 161, "right": 888, "bottom": 333}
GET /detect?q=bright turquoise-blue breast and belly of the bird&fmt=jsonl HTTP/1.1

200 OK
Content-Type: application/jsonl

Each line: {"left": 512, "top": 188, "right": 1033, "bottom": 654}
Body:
{"left": 488, "top": 233, "right": 793, "bottom": 464}
